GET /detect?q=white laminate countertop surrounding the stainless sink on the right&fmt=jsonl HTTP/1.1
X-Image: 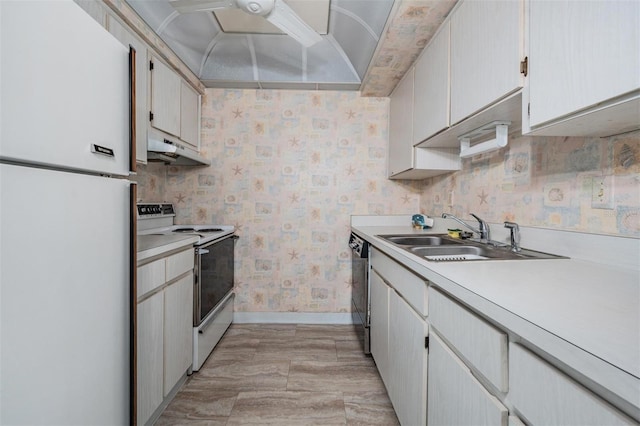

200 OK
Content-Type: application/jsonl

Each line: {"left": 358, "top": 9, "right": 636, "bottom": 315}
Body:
{"left": 352, "top": 226, "right": 640, "bottom": 413}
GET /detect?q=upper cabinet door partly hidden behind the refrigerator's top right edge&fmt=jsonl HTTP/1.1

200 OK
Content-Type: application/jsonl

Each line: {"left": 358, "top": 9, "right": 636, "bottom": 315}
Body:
{"left": 108, "top": 16, "right": 149, "bottom": 164}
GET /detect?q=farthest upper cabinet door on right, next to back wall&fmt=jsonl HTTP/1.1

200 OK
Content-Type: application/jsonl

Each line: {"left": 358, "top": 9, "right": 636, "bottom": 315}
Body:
{"left": 388, "top": 68, "right": 414, "bottom": 176}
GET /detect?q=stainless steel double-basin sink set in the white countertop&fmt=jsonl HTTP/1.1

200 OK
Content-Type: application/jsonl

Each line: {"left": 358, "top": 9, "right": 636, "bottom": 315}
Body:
{"left": 378, "top": 234, "right": 566, "bottom": 262}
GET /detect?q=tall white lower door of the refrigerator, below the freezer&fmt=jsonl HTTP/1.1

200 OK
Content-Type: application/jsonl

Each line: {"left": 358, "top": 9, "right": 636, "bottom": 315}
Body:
{"left": 0, "top": 164, "right": 132, "bottom": 425}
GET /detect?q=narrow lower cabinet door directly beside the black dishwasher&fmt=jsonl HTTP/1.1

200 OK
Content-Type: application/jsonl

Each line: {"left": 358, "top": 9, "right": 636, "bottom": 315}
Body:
{"left": 369, "top": 270, "right": 390, "bottom": 386}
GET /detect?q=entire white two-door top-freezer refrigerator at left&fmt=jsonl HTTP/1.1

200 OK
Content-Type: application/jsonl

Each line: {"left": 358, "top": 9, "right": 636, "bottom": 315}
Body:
{"left": 0, "top": 0, "right": 135, "bottom": 425}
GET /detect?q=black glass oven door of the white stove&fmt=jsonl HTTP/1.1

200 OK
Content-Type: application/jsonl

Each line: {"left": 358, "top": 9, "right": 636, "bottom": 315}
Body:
{"left": 193, "top": 234, "right": 238, "bottom": 327}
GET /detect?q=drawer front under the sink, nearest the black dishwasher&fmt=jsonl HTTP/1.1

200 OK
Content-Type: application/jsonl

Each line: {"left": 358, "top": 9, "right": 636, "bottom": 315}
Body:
{"left": 370, "top": 248, "right": 428, "bottom": 317}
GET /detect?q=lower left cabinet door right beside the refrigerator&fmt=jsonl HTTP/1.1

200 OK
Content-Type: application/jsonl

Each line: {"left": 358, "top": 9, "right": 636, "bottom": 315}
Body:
{"left": 137, "top": 292, "right": 164, "bottom": 425}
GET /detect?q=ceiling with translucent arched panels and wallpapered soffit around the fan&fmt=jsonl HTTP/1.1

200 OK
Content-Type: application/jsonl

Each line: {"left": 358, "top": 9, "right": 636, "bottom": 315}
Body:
{"left": 126, "top": 0, "right": 456, "bottom": 96}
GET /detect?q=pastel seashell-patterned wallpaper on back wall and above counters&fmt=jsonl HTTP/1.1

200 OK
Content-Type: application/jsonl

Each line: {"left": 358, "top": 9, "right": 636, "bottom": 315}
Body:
{"left": 138, "top": 89, "right": 640, "bottom": 312}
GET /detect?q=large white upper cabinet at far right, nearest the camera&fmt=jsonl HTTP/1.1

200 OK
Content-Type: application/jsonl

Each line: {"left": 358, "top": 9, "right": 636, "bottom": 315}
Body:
{"left": 523, "top": 0, "right": 640, "bottom": 136}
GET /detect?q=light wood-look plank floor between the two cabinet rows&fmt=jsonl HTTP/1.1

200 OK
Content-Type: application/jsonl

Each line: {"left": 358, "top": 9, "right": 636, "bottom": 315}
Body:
{"left": 156, "top": 324, "right": 398, "bottom": 426}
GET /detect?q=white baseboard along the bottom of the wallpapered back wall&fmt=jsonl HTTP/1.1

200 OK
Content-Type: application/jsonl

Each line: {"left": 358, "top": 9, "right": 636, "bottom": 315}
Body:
{"left": 233, "top": 312, "right": 353, "bottom": 324}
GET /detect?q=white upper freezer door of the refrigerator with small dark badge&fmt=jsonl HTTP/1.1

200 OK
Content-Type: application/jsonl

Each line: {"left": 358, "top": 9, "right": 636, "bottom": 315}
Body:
{"left": 0, "top": 0, "right": 130, "bottom": 176}
